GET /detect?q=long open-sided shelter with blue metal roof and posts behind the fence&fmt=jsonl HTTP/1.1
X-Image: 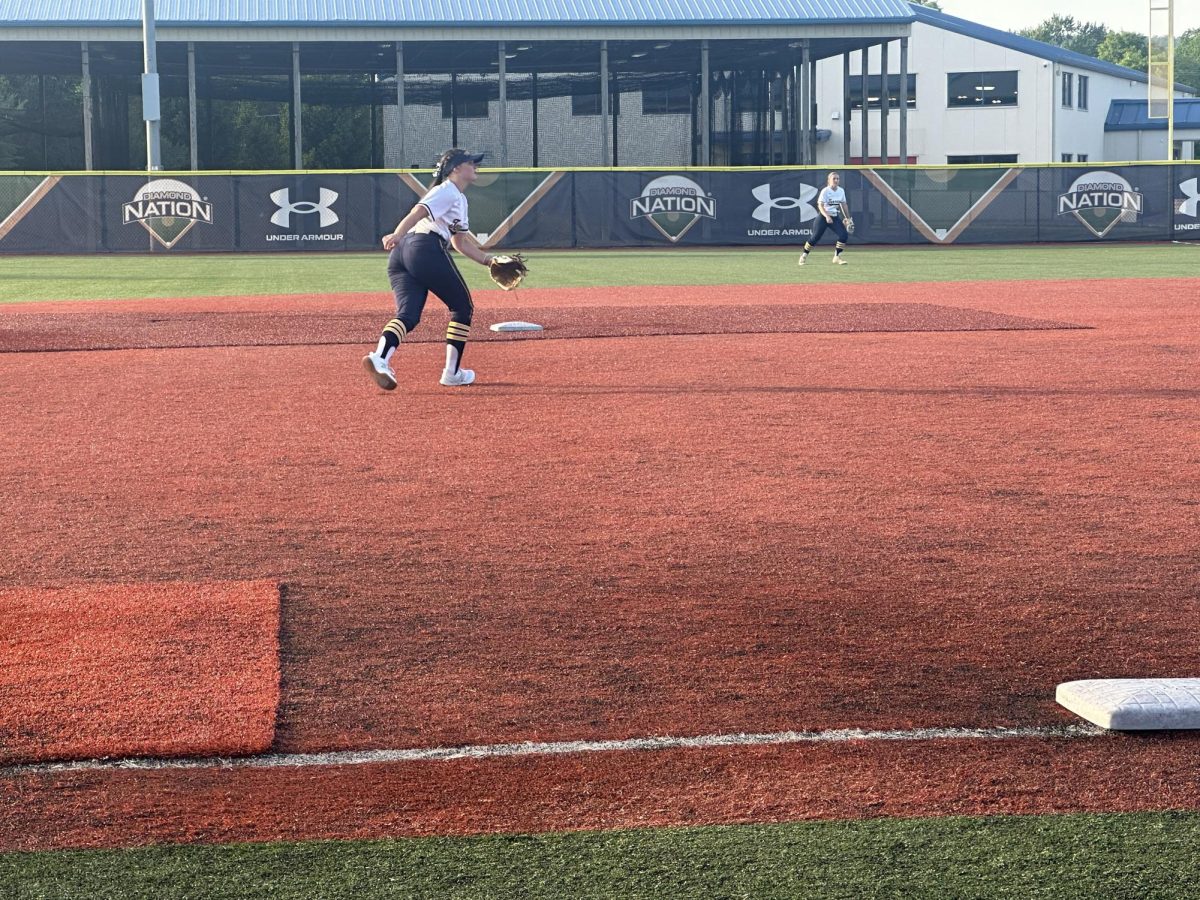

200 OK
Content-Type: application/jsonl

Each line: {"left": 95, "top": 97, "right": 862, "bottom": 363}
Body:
{"left": 0, "top": 0, "right": 914, "bottom": 170}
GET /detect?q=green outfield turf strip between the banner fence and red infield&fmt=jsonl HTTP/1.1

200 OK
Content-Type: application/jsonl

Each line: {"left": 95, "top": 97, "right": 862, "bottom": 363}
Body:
{"left": 0, "top": 242, "right": 1200, "bottom": 304}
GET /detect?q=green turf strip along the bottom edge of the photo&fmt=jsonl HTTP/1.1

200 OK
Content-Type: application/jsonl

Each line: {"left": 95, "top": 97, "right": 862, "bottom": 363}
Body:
{"left": 0, "top": 812, "right": 1200, "bottom": 900}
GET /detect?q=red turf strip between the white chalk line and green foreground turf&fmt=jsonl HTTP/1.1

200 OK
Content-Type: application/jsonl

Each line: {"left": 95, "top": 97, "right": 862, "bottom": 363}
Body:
{"left": 0, "top": 734, "right": 1200, "bottom": 851}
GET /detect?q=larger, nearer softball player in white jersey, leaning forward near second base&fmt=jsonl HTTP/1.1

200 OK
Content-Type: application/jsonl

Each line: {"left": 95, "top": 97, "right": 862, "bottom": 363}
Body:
{"left": 362, "top": 148, "right": 492, "bottom": 391}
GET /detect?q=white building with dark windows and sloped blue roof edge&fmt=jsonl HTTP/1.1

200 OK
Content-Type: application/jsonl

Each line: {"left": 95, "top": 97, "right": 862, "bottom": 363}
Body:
{"left": 816, "top": 4, "right": 1190, "bottom": 166}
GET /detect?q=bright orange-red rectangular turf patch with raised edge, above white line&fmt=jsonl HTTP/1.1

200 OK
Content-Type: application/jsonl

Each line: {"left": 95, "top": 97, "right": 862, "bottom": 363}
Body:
{"left": 0, "top": 582, "right": 280, "bottom": 764}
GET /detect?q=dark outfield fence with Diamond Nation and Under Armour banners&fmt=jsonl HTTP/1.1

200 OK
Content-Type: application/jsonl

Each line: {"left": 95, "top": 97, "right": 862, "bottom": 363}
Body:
{"left": 0, "top": 163, "right": 1200, "bottom": 253}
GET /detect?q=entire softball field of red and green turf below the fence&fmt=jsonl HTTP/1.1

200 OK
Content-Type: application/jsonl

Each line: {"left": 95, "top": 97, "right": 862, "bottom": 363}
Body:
{"left": 0, "top": 245, "right": 1200, "bottom": 900}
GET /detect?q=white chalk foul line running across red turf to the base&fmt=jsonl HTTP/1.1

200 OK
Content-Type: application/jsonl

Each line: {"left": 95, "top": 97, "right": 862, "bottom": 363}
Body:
{"left": 0, "top": 725, "right": 1108, "bottom": 776}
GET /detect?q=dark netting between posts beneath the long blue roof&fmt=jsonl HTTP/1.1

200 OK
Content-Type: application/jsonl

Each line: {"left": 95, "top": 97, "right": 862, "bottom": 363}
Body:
{"left": 0, "top": 41, "right": 840, "bottom": 170}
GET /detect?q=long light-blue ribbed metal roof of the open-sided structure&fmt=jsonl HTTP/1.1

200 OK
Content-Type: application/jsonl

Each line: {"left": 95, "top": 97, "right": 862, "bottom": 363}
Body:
{"left": 0, "top": 0, "right": 913, "bottom": 28}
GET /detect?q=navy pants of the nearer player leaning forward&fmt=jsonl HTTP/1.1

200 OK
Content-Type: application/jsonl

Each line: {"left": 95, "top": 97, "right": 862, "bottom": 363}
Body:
{"left": 388, "top": 234, "right": 475, "bottom": 334}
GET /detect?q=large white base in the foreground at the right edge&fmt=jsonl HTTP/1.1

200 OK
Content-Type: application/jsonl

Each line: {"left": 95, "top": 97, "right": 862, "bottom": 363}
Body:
{"left": 1055, "top": 678, "right": 1200, "bottom": 731}
